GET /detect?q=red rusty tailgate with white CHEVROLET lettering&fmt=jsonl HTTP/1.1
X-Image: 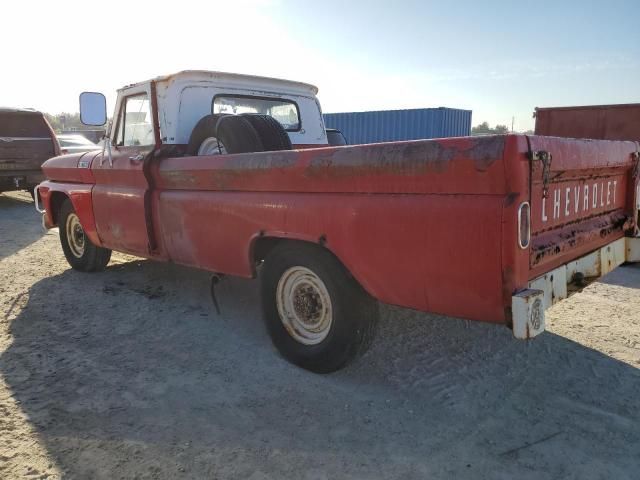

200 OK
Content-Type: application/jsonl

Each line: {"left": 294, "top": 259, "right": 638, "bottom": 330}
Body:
{"left": 528, "top": 136, "right": 638, "bottom": 278}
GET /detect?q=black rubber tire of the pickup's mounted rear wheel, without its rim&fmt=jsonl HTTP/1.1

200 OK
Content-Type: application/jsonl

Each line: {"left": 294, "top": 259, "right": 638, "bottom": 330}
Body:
{"left": 260, "top": 243, "right": 379, "bottom": 373}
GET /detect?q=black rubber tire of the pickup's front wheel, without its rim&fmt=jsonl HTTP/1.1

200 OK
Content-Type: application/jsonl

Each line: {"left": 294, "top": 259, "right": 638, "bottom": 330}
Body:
{"left": 58, "top": 199, "right": 111, "bottom": 272}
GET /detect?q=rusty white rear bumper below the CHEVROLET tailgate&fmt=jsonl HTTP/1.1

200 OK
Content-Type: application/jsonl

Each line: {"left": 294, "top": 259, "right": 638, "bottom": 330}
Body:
{"left": 511, "top": 237, "right": 640, "bottom": 339}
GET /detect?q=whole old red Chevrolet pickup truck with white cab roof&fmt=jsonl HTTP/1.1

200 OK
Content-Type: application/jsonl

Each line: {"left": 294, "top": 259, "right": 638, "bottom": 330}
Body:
{"left": 37, "top": 72, "right": 640, "bottom": 372}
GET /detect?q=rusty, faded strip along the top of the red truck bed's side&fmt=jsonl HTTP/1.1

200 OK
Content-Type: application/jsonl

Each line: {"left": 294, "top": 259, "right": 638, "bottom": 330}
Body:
{"left": 161, "top": 136, "right": 505, "bottom": 190}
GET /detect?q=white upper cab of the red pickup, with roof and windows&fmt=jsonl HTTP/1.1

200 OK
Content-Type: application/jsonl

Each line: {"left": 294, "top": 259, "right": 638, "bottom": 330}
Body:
{"left": 93, "top": 71, "right": 327, "bottom": 152}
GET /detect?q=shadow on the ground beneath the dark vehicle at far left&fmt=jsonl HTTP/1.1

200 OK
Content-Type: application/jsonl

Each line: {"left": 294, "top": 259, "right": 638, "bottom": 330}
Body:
{"left": 0, "top": 192, "right": 45, "bottom": 260}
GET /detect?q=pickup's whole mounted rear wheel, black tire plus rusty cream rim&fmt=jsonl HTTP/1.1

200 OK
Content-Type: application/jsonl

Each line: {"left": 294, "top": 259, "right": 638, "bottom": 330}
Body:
{"left": 260, "top": 243, "right": 378, "bottom": 373}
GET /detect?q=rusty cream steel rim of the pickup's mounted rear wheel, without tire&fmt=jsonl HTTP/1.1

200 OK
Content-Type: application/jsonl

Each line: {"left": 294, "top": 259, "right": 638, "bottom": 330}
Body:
{"left": 276, "top": 267, "right": 333, "bottom": 345}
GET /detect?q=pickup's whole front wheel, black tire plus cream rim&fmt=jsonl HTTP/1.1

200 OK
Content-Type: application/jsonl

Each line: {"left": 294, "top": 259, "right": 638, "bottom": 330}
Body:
{"left": 58, "top": 200, "right": 111, "bottom": 272}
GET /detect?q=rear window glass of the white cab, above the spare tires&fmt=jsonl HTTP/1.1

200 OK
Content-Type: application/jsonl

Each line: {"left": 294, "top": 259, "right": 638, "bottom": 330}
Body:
{"left": 212, "top": 95, "right": 300, "bottom": 132}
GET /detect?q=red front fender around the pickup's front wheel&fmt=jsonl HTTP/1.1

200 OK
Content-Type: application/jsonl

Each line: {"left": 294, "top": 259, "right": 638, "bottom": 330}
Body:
{"left": 38, "top": 181, "right": 102, "bottom": 246}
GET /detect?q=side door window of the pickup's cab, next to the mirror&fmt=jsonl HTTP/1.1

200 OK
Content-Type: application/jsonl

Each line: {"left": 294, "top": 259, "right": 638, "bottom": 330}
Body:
{"left": 116, "top": 93, "right": 155, "bottom": 147}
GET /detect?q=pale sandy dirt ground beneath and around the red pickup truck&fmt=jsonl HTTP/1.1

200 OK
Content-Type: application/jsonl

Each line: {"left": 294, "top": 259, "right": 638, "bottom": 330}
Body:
{"left": 0, "top": 193, "right": 640, "bottom": 480}
